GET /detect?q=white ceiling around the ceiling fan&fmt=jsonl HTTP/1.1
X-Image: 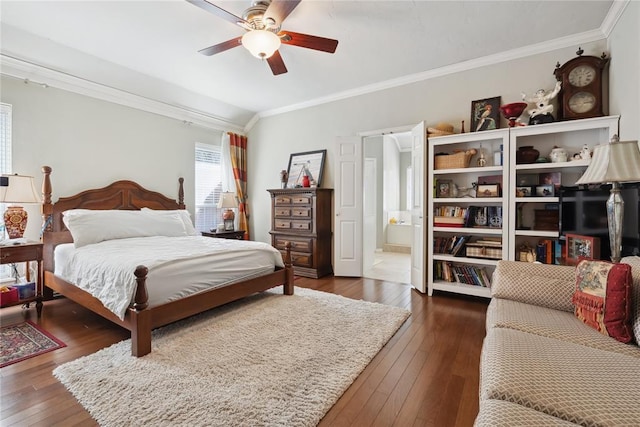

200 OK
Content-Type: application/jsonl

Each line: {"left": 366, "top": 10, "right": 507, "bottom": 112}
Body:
{"left": 0, "top": 0, "right": 624, "bottom": 131}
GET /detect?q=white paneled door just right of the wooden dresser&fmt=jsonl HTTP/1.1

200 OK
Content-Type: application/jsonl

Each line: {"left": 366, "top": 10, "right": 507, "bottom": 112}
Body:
{"left": 333, "top": 136, "right": 362, "bottom": 277}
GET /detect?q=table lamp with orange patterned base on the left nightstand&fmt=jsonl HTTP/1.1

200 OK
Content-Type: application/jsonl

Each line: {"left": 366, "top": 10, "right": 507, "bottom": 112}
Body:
{"left": 0, "top": 174, "right": 40, "bottom": 239}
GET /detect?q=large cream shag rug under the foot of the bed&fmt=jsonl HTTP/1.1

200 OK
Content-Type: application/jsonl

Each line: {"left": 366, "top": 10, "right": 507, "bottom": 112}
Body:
{"left": 53, "top": 287, "right": 410, "bottom": 427}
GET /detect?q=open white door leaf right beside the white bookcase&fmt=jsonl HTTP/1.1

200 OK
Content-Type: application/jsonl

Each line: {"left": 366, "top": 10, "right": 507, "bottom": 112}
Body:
{"left": 411, "top": 122, "right": 428, "bottom": 293}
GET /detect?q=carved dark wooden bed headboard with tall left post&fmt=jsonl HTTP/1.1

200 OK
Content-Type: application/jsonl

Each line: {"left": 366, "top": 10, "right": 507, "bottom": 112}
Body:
{"left": 42, "top": 166, "right": 185, "bottom": 271}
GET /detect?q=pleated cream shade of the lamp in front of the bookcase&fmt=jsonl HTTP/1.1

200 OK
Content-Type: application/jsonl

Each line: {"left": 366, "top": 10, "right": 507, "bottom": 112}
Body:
{"left": 576, "top": 136, "right": 640, "bottom": 184}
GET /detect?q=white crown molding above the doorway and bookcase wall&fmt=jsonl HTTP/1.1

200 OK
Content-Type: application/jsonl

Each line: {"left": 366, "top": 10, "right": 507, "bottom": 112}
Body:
{"left": 244, "top": 26, "right": 608, "bottom": 132}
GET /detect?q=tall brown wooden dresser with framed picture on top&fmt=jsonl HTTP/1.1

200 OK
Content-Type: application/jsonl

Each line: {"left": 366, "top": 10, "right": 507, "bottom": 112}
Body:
{"left": 267, "top": 188, "right": 333, "bottom": 279}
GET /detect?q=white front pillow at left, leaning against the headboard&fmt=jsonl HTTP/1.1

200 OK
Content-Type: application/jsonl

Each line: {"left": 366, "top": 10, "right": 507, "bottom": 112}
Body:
{"left": 63, "top": 209, "right": 187, "bottom": 248}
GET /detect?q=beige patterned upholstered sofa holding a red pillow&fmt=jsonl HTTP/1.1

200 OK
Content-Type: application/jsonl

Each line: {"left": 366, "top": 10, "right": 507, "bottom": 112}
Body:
{"left": 475, "top": 257, "right": 640, "bottom": 427}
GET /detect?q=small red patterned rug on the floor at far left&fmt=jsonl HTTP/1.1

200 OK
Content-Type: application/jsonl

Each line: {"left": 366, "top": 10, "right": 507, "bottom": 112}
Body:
{"left": 0, "top": 320, "right": 66, "bottom": 368}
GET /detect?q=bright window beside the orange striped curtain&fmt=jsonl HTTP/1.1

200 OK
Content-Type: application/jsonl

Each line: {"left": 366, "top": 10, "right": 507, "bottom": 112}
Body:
{"left": 195, "top": 143, "right": 222, "bottom": 231}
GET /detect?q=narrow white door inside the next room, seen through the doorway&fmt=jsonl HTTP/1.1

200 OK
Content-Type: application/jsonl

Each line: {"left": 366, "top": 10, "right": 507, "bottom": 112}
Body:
{"left": 362, "top": 158, "right": 378, "bottom": 273}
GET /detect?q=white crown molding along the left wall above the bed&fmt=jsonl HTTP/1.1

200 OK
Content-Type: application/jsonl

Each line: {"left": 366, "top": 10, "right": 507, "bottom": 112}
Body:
{"left": 0, "top": 54, "right": 243, "bottom": 133}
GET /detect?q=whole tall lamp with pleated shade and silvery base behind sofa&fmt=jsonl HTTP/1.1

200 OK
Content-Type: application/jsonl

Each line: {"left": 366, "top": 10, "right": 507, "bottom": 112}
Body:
{"left": 576, "top": 135, "right": 640, "bottom": 262}
